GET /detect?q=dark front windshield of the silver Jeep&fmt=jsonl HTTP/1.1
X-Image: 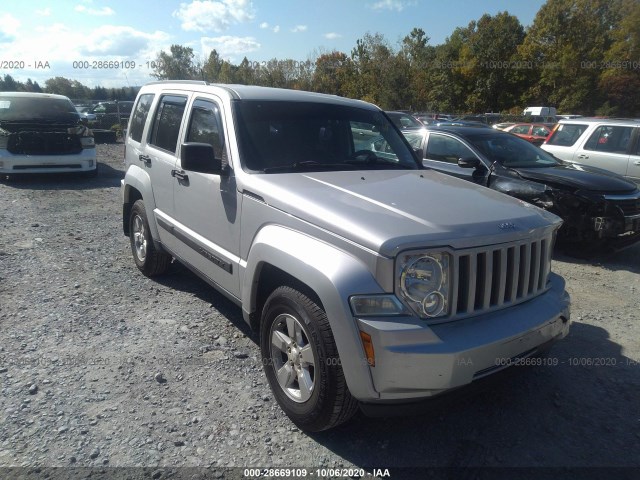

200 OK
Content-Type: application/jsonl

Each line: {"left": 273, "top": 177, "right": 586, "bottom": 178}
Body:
{"left": 234, "top": 100, "right": 420, "bottom": 173}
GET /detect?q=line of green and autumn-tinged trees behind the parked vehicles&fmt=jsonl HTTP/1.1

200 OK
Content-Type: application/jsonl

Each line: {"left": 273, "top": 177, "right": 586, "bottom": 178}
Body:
{"left": 0, "top": 0, "right": 640, "bottom": 116}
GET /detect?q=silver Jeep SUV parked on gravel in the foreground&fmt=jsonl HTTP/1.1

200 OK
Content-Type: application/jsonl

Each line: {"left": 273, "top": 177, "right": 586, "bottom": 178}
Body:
{"left": 122, "top": 82, "right": 570, "bottom": 431}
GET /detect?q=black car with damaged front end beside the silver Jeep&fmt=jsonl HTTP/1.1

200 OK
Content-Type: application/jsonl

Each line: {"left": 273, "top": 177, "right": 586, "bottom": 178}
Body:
{"left": 410, "top": 127, "right": 640, "bottom": 250}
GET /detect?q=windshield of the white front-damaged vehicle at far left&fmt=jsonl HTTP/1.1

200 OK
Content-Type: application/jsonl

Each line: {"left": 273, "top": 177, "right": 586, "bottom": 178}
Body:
{"left": 0, "top": 95, "right": 79, "bottom": 123}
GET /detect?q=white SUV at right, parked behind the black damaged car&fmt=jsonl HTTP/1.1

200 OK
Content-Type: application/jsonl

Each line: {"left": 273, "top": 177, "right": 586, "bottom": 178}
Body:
{"left": 542, "top": 118, "right": 640, "bottom": 183}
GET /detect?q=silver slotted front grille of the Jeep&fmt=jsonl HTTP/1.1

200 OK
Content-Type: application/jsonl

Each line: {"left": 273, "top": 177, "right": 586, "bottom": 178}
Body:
{"left": 449, "top": 235, "right": 553, "bottom": 319}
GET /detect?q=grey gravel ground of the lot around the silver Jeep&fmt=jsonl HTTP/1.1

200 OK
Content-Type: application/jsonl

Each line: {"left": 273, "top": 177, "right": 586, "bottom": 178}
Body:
{"left": 0, "top": 144, "right": 640, "bottom": 478}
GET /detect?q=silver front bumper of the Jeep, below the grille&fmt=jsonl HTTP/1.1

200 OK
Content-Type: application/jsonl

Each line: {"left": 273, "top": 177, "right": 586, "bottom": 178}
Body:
{"left": 357, "top": 274, "right": 570, "bottom": 403}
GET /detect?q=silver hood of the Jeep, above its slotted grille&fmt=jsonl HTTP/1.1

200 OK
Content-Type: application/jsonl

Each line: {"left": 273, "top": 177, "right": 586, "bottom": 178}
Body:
{"left": 244, "top": 170, "right": 560, "bottom": 256}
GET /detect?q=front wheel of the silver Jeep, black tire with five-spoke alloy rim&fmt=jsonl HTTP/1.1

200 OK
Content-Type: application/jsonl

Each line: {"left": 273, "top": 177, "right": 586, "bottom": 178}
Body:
{"left": 260, "top": 286, "right": 358, "bottom": 432}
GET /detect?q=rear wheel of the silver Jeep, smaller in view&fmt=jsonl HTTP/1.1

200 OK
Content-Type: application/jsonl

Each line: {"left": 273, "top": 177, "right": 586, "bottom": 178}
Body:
{"left": 129, "top": 200, "right": 171, "bottom": 277}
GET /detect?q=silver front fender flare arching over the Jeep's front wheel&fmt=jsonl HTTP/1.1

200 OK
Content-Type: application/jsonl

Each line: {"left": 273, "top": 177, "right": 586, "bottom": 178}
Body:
{"left": 241, "top": 225, "right": 383, "bottom": 398}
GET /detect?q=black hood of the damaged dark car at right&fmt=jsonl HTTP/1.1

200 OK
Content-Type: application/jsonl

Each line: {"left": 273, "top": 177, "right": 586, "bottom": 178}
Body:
{"left": 513, "top": 163, "right": 636, "bottom": 193}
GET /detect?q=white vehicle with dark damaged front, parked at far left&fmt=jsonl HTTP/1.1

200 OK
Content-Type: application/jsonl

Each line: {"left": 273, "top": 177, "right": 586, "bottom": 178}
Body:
{"left": 0, "top": 92, "right": 97, "bottom": 176}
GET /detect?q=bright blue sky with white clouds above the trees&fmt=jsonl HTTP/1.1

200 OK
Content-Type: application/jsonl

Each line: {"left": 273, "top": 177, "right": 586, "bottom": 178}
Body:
{"left": 0, "top": 0, "right": 544, "bottom": 87}
